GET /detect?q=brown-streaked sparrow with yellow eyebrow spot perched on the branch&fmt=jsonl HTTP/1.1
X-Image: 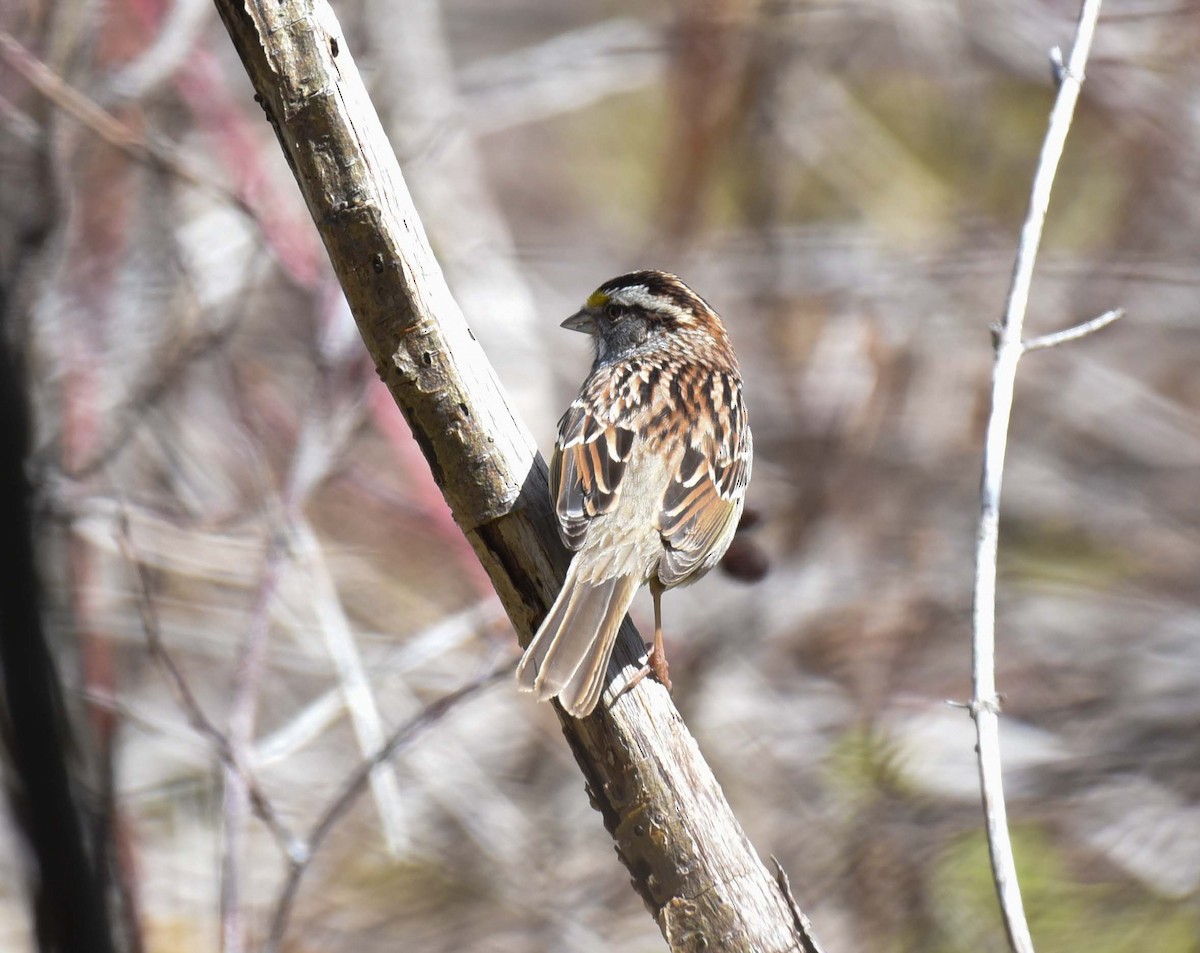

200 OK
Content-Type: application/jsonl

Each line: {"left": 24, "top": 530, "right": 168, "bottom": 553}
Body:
{"left": 517, "top": 271, "right": 754, "bottom": 718}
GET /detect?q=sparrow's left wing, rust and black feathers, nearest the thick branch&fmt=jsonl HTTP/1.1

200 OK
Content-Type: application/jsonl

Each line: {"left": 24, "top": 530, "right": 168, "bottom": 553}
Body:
{"left": 550, "top": 398, "right": 634, "bottom": 550}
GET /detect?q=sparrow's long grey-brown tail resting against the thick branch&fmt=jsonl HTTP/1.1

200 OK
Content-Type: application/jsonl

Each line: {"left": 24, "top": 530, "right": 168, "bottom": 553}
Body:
{"left": 517, "top": 564, "right": 642, "bottom": 718}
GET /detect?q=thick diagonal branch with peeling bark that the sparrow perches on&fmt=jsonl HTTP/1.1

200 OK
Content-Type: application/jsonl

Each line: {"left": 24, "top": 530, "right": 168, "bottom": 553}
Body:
{"left": 208, "top": 0, "right": 804, "bottom": 953}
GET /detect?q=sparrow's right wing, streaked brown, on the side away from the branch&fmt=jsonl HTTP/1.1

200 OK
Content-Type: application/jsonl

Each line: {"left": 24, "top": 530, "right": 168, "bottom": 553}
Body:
{"left": 659, "top": 374, "right": 752, "bottom": 588}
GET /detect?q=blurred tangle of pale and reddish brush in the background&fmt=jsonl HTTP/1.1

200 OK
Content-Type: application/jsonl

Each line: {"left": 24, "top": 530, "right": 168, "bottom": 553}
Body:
{"left": 0, "top": 0, "right": 1200, "bottom": 953}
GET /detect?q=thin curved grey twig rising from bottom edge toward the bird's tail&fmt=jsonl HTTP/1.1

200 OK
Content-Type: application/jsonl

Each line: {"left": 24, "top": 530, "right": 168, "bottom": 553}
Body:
{"left": 264, "top": 659, "right": 516, "bottom": 953}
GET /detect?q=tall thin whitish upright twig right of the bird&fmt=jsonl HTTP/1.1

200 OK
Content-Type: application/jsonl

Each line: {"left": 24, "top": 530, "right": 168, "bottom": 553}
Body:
{"left": 968, "top": 0, "right": 1100, "bottom": 953}
